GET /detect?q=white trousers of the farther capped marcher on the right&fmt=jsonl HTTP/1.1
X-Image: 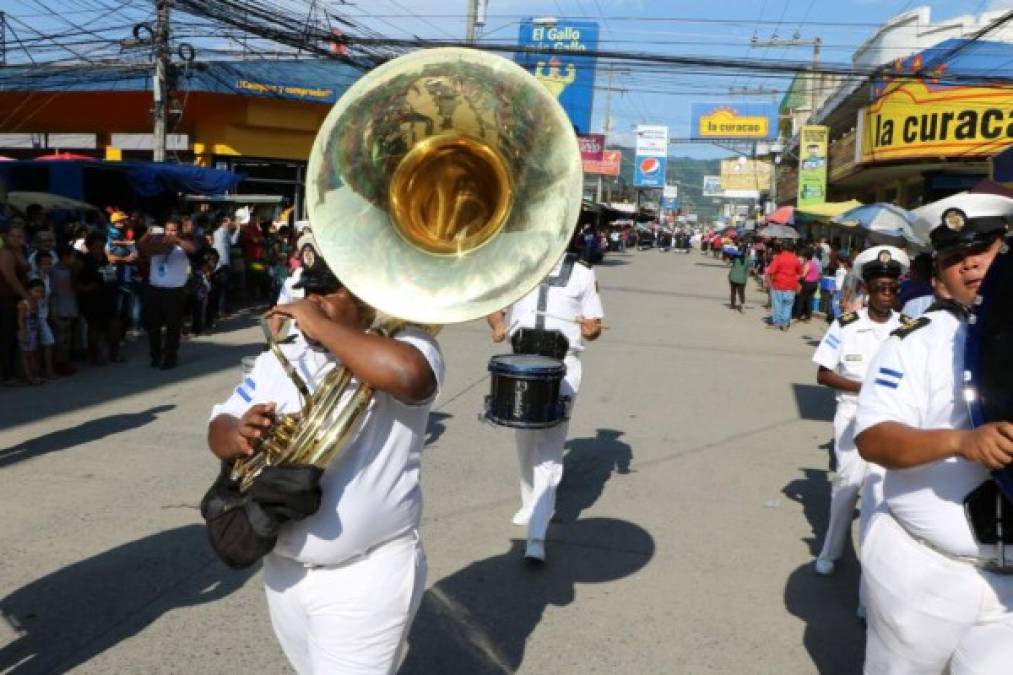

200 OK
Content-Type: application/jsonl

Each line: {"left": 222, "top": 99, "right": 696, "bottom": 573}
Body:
{"left": 820, "top": 401, "right": 871, "bottom": 560}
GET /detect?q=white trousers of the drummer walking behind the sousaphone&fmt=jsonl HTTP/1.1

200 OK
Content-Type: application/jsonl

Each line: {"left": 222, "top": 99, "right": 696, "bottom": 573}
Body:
{"left": 515, "top": 355, "right": 581, "bottom": 540}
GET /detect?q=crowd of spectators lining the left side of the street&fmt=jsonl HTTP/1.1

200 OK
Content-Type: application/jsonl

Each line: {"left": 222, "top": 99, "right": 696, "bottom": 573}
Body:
{"left": 0, "top": 202, "right": 305, "bottom": 385}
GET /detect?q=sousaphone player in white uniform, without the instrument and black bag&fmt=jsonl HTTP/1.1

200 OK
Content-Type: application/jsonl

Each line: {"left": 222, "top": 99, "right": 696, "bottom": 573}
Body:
{"left": 208, "top": 258, "right": 444, "bottom": 674}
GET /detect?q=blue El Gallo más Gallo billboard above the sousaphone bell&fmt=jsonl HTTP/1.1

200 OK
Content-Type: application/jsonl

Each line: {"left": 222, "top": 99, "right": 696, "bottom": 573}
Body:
{"left": 517, "top": 19, "right": 598, "bottom": 134}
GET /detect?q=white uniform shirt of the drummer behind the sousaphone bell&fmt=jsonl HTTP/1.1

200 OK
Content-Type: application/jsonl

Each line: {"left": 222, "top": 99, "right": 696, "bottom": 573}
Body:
{"left": 507, "top": 255, "right": 605, "bottom": 354}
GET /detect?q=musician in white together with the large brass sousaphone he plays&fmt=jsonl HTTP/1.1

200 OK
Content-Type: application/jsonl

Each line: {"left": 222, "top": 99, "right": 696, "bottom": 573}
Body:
{"left": 202, "top": 44, "right": 582, "bottom": 675}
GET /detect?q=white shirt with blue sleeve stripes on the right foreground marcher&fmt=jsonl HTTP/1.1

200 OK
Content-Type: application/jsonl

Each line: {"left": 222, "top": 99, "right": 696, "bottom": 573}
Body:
{"left": 855, "top": 310, "right": 994, "bottom": 557}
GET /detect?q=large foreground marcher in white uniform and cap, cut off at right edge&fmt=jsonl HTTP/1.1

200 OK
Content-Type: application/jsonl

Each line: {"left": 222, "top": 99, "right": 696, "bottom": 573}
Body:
{"left": 856, "top": 194, "right": 1013, "bottom": 675}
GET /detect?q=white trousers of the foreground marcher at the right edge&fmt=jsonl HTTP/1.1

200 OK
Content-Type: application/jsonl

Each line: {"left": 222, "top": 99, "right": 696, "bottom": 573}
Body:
{"left": 862, "top": 512, "right": 1013, "bottom": 675}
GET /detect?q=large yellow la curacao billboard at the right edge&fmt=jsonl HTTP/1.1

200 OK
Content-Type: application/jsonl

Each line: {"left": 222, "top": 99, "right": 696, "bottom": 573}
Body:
{"left": 860, "top": 80, "right": 1013, "bottom": 163}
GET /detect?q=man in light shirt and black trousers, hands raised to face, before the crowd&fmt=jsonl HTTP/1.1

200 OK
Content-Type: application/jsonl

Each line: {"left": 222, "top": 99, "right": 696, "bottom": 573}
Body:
{"left": 138, "top": 218, "right": 197, "bottom": 370}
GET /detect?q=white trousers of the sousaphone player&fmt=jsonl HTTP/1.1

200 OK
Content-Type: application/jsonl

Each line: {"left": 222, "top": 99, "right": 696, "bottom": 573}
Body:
{"left": 263, "top": 532, "right": 426, "bottom": 675}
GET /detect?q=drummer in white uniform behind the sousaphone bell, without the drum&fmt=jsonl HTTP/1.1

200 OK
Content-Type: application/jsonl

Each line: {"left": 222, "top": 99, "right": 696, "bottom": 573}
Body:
{"left": 487, "top": 249, "right": 605, "bottom": 563}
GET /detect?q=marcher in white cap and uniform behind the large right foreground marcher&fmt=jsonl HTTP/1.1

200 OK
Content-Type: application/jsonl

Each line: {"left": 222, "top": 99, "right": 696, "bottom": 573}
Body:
{"left": 812, "top": 246, "right": 910, "bottom": 576}
